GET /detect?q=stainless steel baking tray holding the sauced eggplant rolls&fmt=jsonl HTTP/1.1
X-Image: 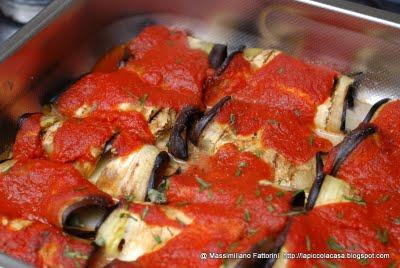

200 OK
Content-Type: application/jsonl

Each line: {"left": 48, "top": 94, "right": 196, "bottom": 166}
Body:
{"left": 0, "top": 0, "right": 400, "bottom": 267}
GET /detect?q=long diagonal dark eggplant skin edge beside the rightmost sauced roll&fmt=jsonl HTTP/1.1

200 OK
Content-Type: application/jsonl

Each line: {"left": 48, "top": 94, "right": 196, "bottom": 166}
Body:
{"left": 330, "top": 123, "right": 376, "bottom": 176}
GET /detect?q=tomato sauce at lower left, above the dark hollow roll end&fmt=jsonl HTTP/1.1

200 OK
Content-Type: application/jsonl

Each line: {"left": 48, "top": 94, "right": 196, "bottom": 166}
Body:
{"left": 0, "top": 160, "right": 112, "bottom": 227}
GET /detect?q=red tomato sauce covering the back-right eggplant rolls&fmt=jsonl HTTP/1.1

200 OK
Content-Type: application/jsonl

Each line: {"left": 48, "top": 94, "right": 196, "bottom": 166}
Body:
{"left": 205, "top": 53, "right": 337, "bottom": 163}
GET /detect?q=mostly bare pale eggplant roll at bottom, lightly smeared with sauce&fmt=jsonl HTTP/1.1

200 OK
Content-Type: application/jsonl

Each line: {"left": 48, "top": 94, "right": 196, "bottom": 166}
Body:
{"left": 92, "top": 203, "right": 193, "bottom": 267}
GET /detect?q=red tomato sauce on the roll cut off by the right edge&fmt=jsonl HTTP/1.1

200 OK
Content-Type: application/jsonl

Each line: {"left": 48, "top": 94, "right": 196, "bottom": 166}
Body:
{"left": 325, "top": 101, "right": 400, "bottom": 203}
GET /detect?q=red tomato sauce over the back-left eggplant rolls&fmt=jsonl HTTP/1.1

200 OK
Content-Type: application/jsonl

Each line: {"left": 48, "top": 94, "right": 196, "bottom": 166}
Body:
{"left": 57, "top": 26, "right": 212, "bottom": 116}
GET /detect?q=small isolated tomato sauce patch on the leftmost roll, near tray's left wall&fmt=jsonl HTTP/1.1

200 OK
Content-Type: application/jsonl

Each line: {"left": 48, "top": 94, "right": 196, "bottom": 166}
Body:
{"left": 13, "top": 113, "right": 43, "bottom": 160}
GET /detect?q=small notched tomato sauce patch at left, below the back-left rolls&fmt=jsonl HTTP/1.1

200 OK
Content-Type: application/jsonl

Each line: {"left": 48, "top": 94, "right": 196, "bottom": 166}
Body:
{"left": 49, "top": 112, "right": 154, "bottom": 163}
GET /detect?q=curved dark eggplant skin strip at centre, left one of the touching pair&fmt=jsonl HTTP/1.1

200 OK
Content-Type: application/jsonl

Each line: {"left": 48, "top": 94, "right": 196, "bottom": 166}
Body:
{"left": 167, "top": 106, "right": 202, "bottom": 160}
